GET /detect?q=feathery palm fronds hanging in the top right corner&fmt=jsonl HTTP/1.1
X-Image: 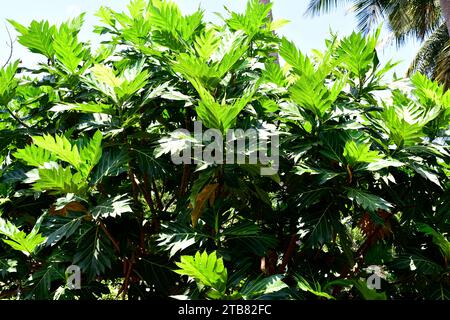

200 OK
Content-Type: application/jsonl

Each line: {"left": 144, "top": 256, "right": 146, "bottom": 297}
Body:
{"left": 307, "top": 0, "right": 450, "bottom": 88}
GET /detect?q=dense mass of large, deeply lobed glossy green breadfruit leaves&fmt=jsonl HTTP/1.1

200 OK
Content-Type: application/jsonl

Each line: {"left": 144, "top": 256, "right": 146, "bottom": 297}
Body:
{"left": 0, "top": 0, "right": 450, "bottom": 299}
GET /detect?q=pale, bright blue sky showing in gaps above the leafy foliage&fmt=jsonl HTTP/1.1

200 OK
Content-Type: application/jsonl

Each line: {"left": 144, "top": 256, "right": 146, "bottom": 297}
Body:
{"left": 0, "top": 0, "right": 420, "bottom": 75}
